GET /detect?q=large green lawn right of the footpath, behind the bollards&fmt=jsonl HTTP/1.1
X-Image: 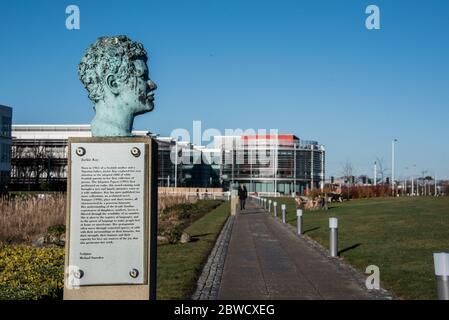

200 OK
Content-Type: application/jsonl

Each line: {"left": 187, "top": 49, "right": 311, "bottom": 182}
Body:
{"left": 268, "top": 197, "right": 449, "bottom": 299}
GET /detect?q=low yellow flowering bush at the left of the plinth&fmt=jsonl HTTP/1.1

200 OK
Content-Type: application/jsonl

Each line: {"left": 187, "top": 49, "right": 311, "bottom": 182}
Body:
{"left": 0, "top": 246, "right": 64, "bottom": 300}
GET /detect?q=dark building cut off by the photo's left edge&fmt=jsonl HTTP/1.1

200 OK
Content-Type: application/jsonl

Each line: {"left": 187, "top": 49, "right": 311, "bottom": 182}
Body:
{"left": 0, "top": 105, "right": 12, "bottom": 193}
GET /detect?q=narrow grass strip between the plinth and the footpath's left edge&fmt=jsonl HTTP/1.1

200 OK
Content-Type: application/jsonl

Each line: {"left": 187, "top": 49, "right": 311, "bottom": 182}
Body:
{"left": 157, "top": 202, "right": 230, "bottom": 300}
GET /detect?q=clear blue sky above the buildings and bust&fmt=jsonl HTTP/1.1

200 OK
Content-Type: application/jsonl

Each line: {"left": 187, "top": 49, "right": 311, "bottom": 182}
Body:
{"left": 0, "top": 0, "right": 449, "bottom": 178}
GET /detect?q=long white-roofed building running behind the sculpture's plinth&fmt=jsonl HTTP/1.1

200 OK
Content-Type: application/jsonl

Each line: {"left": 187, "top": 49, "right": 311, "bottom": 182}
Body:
{"left": 10, "top": 125, "right": 220, "bottom": 190}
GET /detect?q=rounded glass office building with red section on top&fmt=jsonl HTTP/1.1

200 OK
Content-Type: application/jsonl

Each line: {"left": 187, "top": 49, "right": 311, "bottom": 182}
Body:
{"left": 214, "top": 134, "right": 325, "bottom": 194}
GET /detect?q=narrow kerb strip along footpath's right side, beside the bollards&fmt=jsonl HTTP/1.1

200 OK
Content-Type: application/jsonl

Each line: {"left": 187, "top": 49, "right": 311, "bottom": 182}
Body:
{"left": 264, "top": 215, "right": 394, "bottom": 300}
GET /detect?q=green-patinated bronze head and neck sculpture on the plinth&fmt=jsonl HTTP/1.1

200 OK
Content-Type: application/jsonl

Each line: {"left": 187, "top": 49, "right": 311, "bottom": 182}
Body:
{"left": 78, "top": 36, "right": 157, "bottom": 137}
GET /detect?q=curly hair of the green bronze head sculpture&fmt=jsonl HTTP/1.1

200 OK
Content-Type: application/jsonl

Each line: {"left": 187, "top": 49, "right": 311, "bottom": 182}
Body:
{"left": 78, "top": 36, "right": 147, "bottom": 102}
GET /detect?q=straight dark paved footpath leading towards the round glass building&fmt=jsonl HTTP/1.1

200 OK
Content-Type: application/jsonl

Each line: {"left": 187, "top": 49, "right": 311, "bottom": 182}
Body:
{"left": 218, "top": 203, "right": 391, "bottom": 300}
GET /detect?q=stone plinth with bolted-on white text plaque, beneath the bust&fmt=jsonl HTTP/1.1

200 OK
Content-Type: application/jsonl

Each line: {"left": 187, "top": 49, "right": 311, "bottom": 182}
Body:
{"left": 64, "top": 137, "right": 154, "bottom": 299}
